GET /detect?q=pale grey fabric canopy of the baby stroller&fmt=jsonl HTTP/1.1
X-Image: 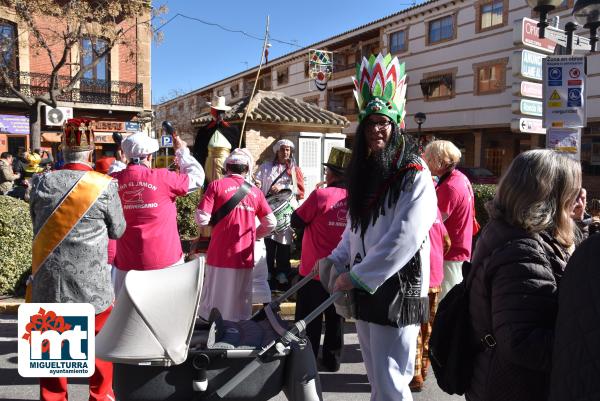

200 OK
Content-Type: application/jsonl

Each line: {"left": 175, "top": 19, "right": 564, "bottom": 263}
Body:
{"left": 96, "top": 258, "right": 204, "bottom": 365}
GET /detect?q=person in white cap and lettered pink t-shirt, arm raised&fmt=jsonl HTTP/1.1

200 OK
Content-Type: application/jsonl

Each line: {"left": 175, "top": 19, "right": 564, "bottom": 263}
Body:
{"left": 109, "top": 132, "right": 204, "bottom": 293}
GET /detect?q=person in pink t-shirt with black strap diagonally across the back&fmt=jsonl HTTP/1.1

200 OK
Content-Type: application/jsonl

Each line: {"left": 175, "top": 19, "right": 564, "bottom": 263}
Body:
{"left": 196, "top": 149, "right": 277, "bottom": 321}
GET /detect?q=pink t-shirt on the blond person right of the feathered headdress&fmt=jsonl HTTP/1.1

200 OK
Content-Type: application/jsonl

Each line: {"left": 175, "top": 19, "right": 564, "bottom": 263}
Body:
{"left": 436, "top": 169, "right": 474, "bottom": 261}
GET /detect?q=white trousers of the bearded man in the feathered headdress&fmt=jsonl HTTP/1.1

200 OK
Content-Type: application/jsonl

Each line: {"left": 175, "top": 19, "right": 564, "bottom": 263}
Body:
{"left": 356, "top": 320, "right": 420, "bottom": 401}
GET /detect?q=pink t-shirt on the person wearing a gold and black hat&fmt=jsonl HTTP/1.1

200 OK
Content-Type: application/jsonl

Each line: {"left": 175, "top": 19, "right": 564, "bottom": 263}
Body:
{"left": 296, "top": 187, "right": 348, "bottom": 279}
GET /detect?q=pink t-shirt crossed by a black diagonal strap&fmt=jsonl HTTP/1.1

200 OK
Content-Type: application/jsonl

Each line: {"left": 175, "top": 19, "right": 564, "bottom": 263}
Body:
{"left": 198, "top": 175, "right": 271, "bottom": 269}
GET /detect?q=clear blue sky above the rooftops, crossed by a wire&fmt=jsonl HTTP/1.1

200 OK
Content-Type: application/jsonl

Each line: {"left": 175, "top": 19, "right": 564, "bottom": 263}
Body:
{"left": 152, "top": 0, "right": 411, "bottom": 101}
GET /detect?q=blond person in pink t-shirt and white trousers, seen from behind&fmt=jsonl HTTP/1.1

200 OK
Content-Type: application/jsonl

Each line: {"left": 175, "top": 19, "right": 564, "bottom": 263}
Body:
{"left": 424, "top": 141, "right": 475, "bottom": 300}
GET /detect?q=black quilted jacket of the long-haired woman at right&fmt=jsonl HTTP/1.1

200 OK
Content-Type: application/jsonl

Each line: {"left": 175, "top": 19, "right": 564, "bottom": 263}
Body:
{"left": 466, "top": 220, "right": 567, "bottom": 401}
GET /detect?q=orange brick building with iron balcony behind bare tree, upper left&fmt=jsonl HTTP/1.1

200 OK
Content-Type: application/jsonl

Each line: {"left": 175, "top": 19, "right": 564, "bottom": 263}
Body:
{"left": 0, "top": 3, "right": 152, "bottom": 157}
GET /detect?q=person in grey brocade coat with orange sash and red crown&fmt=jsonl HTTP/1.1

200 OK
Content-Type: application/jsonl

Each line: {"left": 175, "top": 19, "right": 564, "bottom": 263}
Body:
{"left": 30, "top": 119, "right": 125, "bottom": 401}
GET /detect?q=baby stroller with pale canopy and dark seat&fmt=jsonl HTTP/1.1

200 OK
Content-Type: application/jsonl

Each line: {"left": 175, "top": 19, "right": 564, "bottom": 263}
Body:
{"left": 96, "top": 257, "right": 338, "bottom": 401}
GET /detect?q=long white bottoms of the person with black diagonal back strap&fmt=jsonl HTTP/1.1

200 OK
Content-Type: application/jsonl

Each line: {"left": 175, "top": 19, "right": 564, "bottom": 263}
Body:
{"left": 199, "top": 264, "right": 252, "bottom": 322}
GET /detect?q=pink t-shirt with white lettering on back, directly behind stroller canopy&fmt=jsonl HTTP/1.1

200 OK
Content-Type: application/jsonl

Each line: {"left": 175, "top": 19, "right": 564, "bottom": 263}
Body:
{"left": 113, "top": 165, "right": 189, "bottom": 270}
